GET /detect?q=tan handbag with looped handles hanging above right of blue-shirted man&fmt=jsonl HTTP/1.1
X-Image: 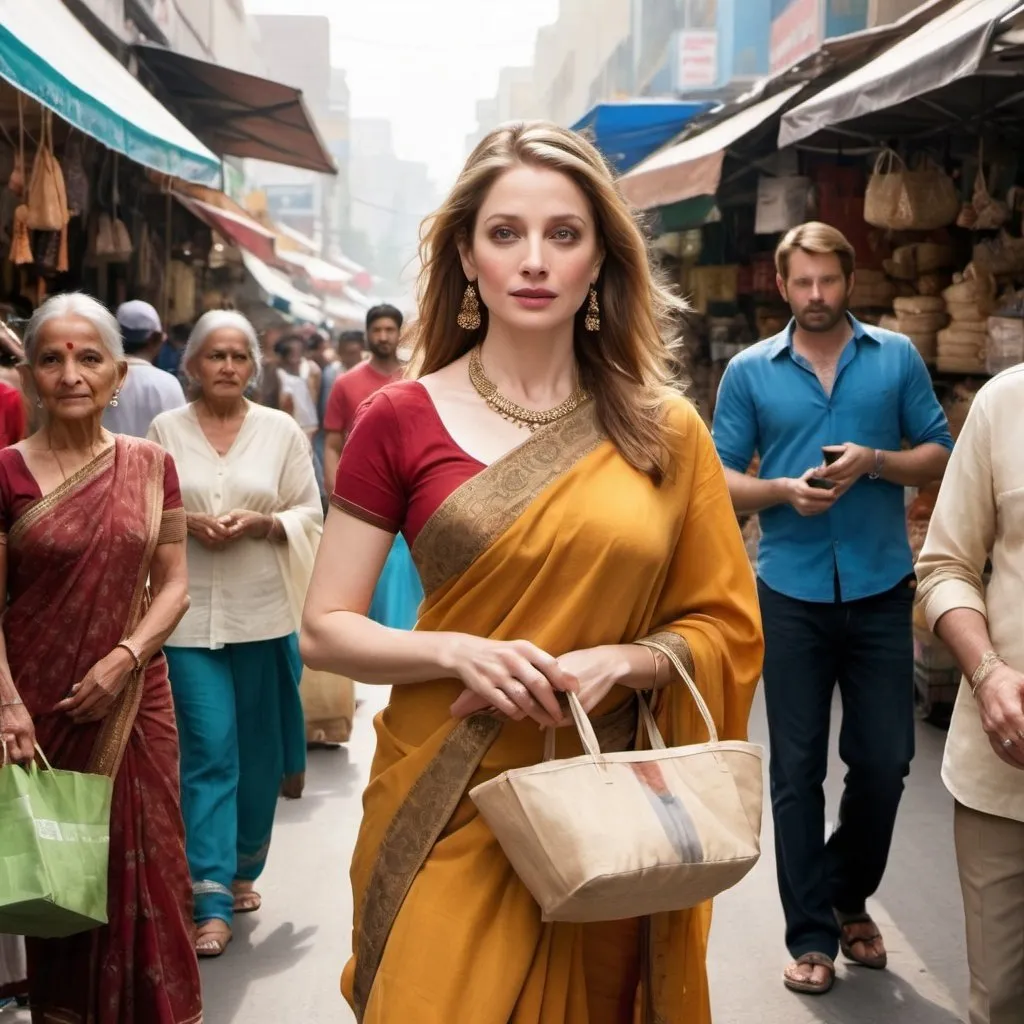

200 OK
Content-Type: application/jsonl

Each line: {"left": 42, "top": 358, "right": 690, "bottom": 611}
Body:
{"left": 864, "top": 150, "right": 961, "bottom": 231}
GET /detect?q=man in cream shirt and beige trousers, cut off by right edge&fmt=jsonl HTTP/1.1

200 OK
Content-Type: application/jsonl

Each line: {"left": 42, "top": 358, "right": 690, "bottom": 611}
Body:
{"left": 918, "top": 366, "right": 1024, "bottom": 1024}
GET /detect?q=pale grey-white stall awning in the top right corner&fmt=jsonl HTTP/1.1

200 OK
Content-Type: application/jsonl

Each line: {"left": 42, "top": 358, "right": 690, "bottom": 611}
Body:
{"left": 778, "top": 0, "right": 1024, "bottom": 147}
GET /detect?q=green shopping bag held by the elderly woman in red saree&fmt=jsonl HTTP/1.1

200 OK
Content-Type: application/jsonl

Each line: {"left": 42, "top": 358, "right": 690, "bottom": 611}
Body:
{"left": 0, "top": 746, "right": 114, "bottom": 939}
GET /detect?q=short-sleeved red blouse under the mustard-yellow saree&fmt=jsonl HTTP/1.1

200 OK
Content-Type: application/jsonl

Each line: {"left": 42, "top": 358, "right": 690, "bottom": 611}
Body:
{"left": 331, "top": 381, "right": 486, "bottom": 547}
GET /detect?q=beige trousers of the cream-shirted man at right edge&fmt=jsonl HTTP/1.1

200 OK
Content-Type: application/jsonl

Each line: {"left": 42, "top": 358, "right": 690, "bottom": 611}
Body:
{"left": 953, "top": 798, "right": 1024, "bottom": 1024}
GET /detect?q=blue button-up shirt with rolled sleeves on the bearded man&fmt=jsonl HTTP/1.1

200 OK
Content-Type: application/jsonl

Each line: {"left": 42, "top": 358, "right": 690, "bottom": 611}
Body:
{"left": 714, "top": 316, "right": 953, "bottom": 602}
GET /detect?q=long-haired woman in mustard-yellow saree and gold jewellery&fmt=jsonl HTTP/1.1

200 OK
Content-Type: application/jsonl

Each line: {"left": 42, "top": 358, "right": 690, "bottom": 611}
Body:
{"left": 302, "top": 124, "right": 762, "bottom": 1024}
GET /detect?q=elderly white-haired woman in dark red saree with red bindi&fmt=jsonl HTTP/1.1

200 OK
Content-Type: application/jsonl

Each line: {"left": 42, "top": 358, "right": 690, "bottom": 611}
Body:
{"left": 0, "top": 295, "right": 203, "bottom": 1024}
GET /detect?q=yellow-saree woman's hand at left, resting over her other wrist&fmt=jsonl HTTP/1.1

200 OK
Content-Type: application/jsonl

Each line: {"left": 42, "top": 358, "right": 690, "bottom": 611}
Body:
{"left": 445, "top": 634, "right": 579, "bottom": 728}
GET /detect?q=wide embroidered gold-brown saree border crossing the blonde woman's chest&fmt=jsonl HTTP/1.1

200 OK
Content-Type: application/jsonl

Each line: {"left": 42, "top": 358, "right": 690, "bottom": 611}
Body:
{"left": 413, "top": 401, "right": 604, "bottom": 597}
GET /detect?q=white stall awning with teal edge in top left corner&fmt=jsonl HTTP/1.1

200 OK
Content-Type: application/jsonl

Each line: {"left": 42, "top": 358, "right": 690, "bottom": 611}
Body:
{"left": 0, "top": 0, "right": 220, "bottom": 184}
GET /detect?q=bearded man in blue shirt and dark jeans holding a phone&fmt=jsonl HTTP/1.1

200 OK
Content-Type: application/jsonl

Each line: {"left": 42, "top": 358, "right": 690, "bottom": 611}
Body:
{"left": 714, "top": 223, "right": 952, "bottom": 993}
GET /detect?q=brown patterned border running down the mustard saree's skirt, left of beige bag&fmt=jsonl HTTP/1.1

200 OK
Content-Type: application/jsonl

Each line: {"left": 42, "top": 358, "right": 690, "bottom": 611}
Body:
{"left": 352, "top": 715, "right": 502, "bottom": 1022}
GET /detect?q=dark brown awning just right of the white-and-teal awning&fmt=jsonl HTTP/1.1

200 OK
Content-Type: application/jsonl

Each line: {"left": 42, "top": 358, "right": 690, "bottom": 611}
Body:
{"left": 135, "top": 44, "right": 338, "bottom": 174}
